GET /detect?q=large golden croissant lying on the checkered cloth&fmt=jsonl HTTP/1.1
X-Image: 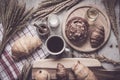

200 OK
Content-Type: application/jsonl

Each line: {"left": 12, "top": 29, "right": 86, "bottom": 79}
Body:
{"left": 12, "top": 36, "right": 42, "bottom": 59}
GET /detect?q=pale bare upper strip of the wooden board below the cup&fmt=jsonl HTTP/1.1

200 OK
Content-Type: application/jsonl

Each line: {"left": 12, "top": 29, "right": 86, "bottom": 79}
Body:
{"left": 33, "top": 58, "right": 101, "bottom": 69}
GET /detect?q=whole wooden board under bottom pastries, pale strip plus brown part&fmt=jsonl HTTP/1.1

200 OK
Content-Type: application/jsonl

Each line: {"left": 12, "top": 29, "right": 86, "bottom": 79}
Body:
{"left": 32, "top": 58, "right": 101, "bottom": 80}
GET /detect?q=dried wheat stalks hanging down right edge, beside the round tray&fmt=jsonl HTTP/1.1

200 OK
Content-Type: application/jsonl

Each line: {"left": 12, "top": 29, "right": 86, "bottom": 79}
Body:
{"left": 103, "top": 0, "right": 120, "bottom": 53}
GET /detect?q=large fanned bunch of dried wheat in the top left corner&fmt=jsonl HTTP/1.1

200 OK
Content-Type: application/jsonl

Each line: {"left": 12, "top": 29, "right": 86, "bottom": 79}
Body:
{"left": 0, "top": 0, "right": 32, "bottom": 56}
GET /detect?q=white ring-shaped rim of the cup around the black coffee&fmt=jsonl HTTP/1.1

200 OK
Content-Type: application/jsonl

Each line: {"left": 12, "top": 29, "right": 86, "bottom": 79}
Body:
{"left": 45, "top": 35, "right": 65, "bottom": 55}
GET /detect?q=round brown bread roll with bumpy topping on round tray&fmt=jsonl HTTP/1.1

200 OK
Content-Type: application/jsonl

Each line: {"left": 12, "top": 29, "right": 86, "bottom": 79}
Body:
{"left": 65, "top": 17, "right": 89, "bottom": 46}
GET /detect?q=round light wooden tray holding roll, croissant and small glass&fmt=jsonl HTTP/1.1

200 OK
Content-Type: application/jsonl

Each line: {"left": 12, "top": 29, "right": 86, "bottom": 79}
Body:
{"left": 62, "top": 5, "right": 111, "bottom": 52}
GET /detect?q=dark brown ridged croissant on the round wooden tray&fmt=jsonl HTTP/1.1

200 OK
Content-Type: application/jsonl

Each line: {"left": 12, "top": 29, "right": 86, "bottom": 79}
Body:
{"left": 90, "top": 26, "right": 105, "bottom": 48}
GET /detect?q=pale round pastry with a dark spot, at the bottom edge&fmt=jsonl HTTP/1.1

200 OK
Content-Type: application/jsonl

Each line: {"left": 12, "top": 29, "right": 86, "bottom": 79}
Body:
{"left": 35, "top": 70, "right": 50, "bottom": 80}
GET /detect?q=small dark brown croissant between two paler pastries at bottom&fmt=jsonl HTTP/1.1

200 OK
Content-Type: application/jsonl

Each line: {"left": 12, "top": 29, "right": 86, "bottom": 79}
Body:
{"left": 56, "top": 63, "right": 69, "bottom": 80}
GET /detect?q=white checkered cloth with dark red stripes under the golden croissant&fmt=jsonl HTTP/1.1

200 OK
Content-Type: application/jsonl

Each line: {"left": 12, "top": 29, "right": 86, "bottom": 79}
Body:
{"left": 0, "top": 24, "right": 48, "bottom": 80}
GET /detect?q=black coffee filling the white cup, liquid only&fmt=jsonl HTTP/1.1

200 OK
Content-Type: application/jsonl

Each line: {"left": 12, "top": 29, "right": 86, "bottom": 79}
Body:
{"left": 47, "top": 36, "right": 64, "bottom": 53}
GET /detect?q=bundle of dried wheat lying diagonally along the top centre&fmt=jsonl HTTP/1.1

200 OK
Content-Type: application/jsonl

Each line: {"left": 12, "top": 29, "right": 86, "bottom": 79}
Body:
{"left": 33, "top": 0, "right": 82, "bottom": 20}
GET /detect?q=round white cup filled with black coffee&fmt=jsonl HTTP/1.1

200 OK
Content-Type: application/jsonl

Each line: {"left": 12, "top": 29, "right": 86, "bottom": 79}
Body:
{"left": 45, "top": 35, "right": 65, "bottom": 55}
